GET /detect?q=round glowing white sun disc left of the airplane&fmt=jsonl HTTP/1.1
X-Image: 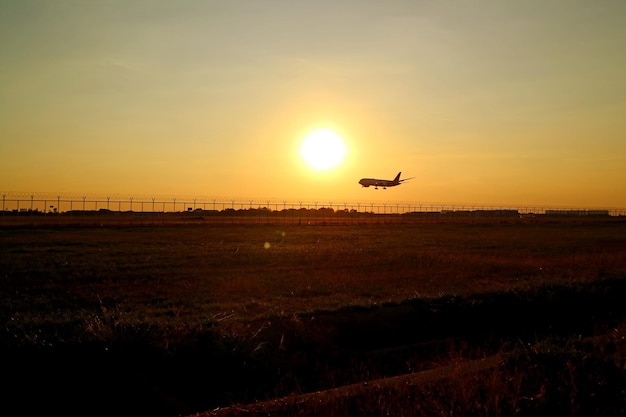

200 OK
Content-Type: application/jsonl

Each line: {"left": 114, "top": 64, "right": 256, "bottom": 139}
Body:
{"left": 300, "top": 129, "right": 346, "bottom": 171}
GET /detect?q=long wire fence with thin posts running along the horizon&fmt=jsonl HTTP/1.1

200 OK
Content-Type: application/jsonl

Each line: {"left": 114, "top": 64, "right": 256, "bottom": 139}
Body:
{"left": 1, "top": 193, "right": 626, "bottom": 217}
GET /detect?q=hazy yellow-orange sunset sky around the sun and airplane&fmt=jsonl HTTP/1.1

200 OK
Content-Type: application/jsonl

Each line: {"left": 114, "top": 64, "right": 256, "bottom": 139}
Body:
{"left": 0, "top": 0, "right": 626, "bottom": 208}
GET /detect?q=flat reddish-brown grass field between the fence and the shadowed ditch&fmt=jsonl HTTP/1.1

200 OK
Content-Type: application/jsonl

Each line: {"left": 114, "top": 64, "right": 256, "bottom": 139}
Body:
{"left": 0, "top": 218, "right": 626, "bottom": 338}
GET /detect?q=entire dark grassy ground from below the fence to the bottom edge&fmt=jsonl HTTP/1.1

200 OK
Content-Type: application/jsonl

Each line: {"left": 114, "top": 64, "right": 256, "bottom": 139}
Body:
{"left": 0, "top": 217, "right": 626, "bottom": 417}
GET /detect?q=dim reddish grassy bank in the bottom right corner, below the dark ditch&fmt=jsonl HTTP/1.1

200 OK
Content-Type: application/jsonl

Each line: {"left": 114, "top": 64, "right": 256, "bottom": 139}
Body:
{"left": 196, "top": 325, "right": 626, "bottom": 417}
